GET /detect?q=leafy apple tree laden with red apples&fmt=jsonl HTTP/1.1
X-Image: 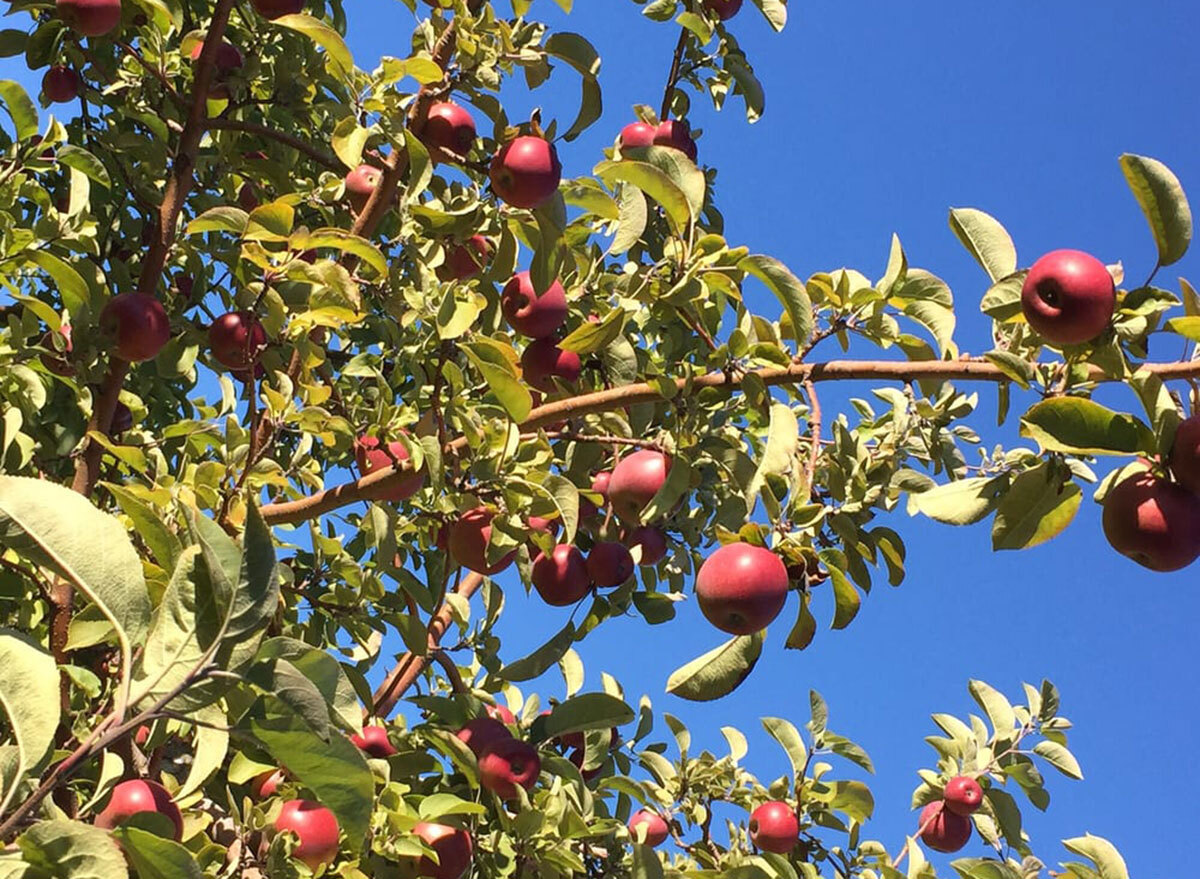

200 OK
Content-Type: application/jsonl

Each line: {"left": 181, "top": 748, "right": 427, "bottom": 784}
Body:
{"left": 0, "top": 0, "right": 1200, "bottom": 879}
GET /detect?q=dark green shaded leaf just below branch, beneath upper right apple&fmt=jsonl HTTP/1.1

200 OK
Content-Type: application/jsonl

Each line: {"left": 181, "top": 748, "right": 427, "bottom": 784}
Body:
{"left": 1021, "top": 396, "right": 1158, "bottom": 455}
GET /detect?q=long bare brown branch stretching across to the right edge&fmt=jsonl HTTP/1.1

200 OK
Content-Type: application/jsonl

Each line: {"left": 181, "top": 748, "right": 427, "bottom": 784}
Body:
{"left": 262, "top": 358, "right": 1200, "bottom": 525}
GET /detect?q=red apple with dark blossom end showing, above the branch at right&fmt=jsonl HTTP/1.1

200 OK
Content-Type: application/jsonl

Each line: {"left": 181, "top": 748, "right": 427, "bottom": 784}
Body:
{"left": 1021, "top": 250, "right": 1116, "bottom": 345}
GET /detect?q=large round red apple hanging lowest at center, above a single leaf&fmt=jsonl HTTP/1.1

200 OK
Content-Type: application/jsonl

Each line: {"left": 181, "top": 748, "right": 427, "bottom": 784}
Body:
{"left": 696, "top": 543, "right": 787, "bottom": 635}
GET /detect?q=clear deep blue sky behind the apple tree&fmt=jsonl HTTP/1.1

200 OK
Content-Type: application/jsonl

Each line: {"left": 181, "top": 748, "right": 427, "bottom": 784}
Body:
{"left": 0, "top": 0, "right": 1200, "bottom": 878}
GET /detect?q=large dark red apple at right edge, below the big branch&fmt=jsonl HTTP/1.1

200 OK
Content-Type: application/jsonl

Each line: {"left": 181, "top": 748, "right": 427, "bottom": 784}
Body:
{"left": 1103, "top": 472, "right": 1200, "bottom": 572}
